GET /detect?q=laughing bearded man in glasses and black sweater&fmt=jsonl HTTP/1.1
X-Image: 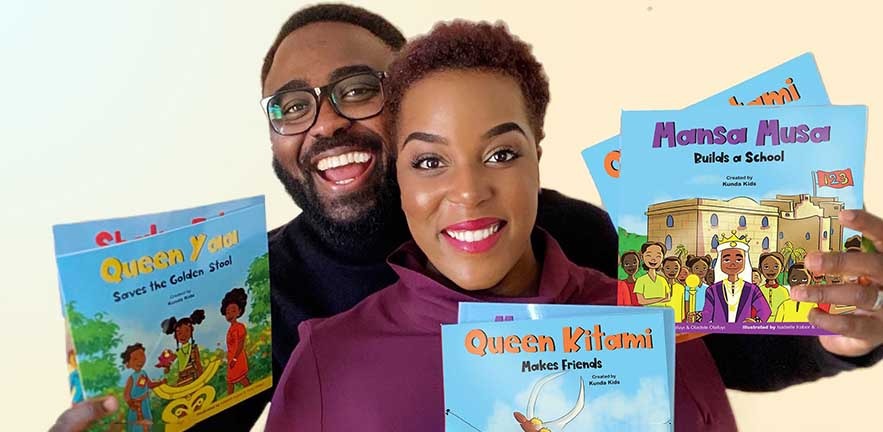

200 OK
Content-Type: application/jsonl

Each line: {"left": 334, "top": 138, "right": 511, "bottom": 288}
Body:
{"left": 50, "top": 5, "right": 883, "bottom": 431}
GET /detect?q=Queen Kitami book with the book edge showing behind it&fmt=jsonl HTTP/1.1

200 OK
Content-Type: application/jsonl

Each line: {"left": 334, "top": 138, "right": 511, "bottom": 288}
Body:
{"left": 442, "top": 303, "right": 674, "bottom": 432}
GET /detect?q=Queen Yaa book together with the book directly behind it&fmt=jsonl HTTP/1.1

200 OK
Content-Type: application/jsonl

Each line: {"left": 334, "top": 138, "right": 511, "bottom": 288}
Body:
{"left": 53, "top": 196, "right": 273, "bottom": 431}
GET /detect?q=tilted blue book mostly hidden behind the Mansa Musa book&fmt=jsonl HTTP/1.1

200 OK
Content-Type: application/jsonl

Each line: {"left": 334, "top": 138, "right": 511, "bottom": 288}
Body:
{"left": 582, "top": 53, "right": 830, "bottom": 226}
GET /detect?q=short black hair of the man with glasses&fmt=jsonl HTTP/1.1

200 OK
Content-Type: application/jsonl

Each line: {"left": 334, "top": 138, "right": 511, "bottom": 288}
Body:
{"left": 261, "top": 4, "right": 405, "bottom": 86}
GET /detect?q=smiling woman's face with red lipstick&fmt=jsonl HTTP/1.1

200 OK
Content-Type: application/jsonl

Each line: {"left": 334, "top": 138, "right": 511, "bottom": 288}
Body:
{"left": 395, "top": 71, "right": 540, "bottom": 290}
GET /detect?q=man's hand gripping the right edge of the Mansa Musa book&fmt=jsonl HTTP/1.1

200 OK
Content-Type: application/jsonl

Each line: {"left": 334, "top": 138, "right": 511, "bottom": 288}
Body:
{"left": 791, "top": 210, "right": 883, "bottom": 357}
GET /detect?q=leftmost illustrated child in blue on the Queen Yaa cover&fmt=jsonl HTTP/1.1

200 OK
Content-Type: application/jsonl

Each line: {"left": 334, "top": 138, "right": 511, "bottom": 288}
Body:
{"left": 120, "top": 343, "right": 166, "bottom": 432}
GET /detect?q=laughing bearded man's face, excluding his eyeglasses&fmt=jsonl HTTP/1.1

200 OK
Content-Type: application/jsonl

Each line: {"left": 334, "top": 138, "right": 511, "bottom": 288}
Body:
{"left": 263, "top": 22, "right": 396, "bottom": 224}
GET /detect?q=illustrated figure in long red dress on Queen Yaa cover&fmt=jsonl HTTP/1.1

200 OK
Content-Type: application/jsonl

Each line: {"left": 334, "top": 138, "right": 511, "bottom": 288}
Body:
{"left": 221, "top": 288, "right": 250, "bottom": 395}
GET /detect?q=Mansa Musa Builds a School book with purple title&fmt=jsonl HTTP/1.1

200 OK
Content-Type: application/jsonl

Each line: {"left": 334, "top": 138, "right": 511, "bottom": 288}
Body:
{"left": 616, "top": 106, "right": 867, "bottom": 335}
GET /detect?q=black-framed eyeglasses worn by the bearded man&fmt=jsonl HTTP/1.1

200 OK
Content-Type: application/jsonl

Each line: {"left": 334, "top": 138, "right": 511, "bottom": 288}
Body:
{"left": 261, "top": 71, "right": 386, "bottom": 135}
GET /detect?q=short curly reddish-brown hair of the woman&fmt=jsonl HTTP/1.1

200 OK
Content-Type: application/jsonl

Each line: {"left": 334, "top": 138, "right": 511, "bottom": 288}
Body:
{"left": 385, "top": 20, "right": 549, "bottom": 142}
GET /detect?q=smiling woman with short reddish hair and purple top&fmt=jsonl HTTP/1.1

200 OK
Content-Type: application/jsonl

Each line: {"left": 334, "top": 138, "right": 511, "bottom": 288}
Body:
{"left": 267, "top": 18, "right": 734, "bottom": 431}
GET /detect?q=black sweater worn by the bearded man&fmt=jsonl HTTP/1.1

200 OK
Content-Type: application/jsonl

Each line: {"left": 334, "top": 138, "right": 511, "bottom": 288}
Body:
{"left": 191, "top": 189, "right": 883, "bottom": 431}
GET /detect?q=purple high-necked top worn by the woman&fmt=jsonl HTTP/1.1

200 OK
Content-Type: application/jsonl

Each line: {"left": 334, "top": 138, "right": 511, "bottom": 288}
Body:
{"left": 267, "top": 233, "right": 735, "bottom": 432}
